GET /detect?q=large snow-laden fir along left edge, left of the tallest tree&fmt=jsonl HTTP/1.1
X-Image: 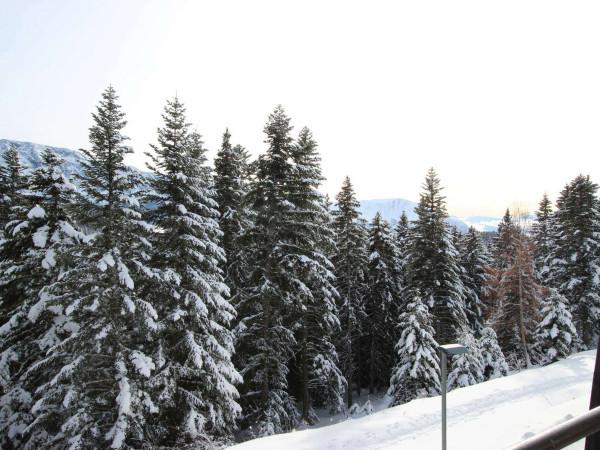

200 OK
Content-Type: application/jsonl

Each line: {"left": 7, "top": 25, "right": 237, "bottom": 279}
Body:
{"left": 0, "top": 150, "right": 85, "bottom": 448}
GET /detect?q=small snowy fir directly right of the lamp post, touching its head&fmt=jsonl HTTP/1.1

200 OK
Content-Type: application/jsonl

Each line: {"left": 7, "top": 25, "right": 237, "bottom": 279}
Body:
{"left": 448, "top": 330, "right": 484, "bottom": 390}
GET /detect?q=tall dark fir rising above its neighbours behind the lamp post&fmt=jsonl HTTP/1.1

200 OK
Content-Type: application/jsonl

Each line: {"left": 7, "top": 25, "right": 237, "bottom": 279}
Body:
{"left": 407, "top": 168, "right": 467, "bottom": 344}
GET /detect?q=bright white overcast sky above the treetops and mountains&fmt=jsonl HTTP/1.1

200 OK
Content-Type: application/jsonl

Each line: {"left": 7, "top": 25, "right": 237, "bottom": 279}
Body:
{"left": 0, "top": 0, "right": 600, "bottom": 215}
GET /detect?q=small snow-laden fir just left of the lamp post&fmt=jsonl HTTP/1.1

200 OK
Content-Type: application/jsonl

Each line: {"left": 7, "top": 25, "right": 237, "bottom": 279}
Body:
{"left": 388, "top": 290, "right": 440, "bottom": 406}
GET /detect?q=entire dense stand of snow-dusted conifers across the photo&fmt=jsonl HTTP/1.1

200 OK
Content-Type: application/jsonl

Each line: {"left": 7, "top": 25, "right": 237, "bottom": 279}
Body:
{"left": 0, "top": 87, "right": 600, "bottom": 449}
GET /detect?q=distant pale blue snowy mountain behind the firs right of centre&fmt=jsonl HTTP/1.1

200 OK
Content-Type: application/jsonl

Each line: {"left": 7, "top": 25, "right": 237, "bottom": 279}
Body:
{"left": 360, "top": 198, "right": 500, "bottom": 232}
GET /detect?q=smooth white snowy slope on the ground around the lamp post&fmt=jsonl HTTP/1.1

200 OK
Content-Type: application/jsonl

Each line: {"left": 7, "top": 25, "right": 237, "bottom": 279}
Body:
{"left": 231, "top": 351, "right": 596, "bottom": 450}
